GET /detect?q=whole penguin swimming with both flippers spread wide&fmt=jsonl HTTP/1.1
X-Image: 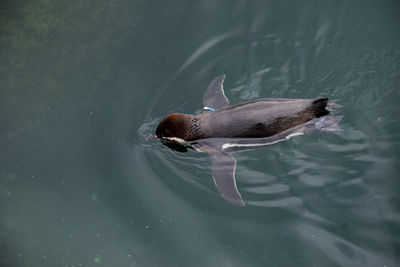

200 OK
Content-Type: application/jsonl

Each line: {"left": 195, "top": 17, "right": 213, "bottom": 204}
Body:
{"left": 155, "top": 75, "right": 343, "bottom": 206}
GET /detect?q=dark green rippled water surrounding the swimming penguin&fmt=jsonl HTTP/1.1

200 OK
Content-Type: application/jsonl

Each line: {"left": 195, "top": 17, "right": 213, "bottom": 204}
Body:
{"left": 0, "top": 0, "right": 400, "bottom": 267}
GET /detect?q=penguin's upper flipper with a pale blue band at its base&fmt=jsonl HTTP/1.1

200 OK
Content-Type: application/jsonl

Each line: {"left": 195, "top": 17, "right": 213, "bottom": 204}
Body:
{"left": 203, "top": 75, "right": 229, "bottom": 110}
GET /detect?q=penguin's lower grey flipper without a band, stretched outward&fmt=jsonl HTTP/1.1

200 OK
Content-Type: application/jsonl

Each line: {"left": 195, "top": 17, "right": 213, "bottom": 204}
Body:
{"left": 195, "top": 144, "right": 244, "bottom": 207}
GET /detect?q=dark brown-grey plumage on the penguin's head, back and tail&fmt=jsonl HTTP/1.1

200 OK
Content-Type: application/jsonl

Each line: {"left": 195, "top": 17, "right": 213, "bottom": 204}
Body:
{"left": 156, "top": 98, "right": 329, "bottom": 141}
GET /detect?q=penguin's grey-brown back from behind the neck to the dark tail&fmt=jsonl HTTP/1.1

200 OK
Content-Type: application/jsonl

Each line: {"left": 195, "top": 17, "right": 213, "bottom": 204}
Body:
{"left": 205, "top": 98, "right": 329, "bottom": 138}
